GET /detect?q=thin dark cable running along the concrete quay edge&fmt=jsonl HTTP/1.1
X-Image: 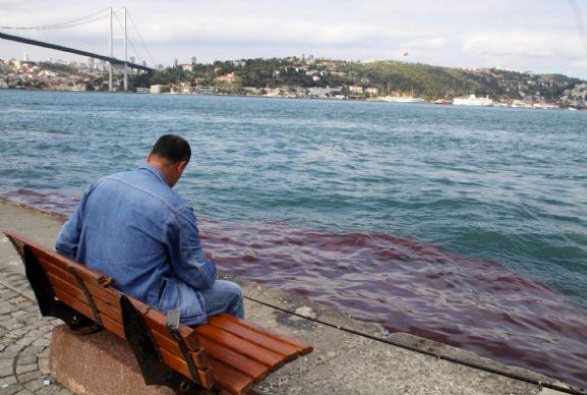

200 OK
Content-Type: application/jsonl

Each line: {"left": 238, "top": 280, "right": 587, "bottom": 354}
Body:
{"left": 244, "top": 295, "right": 587, "bottom": 395}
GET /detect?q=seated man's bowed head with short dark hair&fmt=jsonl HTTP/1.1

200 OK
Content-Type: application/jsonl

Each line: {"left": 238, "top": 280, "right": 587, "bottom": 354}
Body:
{"left": 147, "top": 134, "right": 192, "bottom": 188}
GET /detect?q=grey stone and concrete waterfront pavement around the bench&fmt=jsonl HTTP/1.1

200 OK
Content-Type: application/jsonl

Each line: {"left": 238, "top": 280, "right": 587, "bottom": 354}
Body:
{"left": 0, "top": 201, "right": 560, "bottom": 395}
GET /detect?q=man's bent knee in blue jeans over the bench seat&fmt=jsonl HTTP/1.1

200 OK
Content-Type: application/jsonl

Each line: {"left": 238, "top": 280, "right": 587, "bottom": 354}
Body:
{"left": 199, "top": 280, "right": 245, "bottom": 318}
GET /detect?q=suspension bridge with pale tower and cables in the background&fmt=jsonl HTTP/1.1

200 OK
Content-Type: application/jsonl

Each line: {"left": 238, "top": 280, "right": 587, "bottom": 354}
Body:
{"left": 0, "top": 7, "right": 155, "bottom": 91}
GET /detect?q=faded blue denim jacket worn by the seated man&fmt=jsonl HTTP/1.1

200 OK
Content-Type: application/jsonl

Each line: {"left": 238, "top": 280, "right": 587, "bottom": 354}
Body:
{"left": 55, "top": 165, "right": 216, "bottom": 325}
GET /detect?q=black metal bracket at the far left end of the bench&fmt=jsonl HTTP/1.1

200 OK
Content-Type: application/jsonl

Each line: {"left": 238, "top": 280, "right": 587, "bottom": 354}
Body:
{"left": 22, "top": 245, "right": 100, "bottom": 333}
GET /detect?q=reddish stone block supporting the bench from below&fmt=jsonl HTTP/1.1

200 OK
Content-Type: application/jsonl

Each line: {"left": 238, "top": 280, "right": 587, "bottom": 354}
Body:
{"left": 49, "top": 325, "right": 174, "bottom": 395}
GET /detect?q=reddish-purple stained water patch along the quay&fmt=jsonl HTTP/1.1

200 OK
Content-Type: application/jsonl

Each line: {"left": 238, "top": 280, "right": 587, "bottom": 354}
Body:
{"left": 0, "top": 190, "right": 587, "bottom": 387}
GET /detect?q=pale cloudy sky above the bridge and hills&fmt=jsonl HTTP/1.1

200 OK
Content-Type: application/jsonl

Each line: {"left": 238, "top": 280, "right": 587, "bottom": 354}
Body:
{"left": 0, "top": 0, "right": 587, "bottom": 79}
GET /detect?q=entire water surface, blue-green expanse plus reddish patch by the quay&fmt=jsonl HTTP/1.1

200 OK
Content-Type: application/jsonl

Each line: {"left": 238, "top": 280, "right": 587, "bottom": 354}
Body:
{"left": 0, "top": 91, "right": 587, "bottom": 386}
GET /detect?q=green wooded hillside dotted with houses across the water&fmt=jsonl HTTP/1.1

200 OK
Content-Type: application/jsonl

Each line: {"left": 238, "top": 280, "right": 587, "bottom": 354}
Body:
{"left": 150, "top": 57, "right": 587, "bottom": 107}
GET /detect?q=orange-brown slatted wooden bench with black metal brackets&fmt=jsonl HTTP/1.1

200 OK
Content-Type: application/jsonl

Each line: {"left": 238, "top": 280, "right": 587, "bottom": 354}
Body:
{"left": 4, "top": 231, "right": 312, "bottom": 394}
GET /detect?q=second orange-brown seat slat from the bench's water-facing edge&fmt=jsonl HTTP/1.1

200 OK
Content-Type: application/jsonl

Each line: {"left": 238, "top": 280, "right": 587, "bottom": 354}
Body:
{"left": 194, "top": 325, "right": 285, "bottom": 370}
